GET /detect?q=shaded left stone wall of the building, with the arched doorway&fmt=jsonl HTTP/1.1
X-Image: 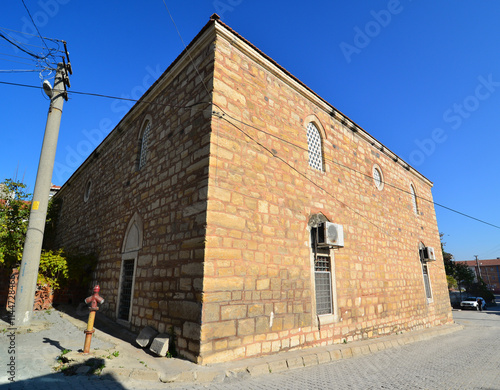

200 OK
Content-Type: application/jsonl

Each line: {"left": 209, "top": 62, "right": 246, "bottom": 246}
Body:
{"left": 57, "top": 40, "right": 213, "bottom": 360}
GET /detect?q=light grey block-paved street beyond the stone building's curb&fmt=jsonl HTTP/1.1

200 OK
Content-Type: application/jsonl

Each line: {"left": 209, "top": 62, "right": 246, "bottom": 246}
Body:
{"left": 164, "top": 311, "right": 500, "bottom": 390}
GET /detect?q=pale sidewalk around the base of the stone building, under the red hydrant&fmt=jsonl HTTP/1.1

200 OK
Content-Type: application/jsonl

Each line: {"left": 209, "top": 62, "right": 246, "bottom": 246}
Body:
{"left": 0, "top": 306, "right": 463, "bottom": 388}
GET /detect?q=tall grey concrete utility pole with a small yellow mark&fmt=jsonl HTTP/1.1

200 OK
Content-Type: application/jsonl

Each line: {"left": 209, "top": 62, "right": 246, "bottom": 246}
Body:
{"left": 14, "top": 63, "right": 71, "bottom": 326}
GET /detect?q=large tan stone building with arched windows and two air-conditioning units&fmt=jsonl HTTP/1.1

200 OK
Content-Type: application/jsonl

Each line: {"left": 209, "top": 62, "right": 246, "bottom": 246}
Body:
{"left": 55, "top": 16, "right": 452, "bottom": 364}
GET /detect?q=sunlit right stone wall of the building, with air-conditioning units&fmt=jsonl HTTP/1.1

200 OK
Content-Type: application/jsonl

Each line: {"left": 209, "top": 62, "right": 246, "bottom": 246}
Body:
{"left": 200, "top": 29, "right": 451, "bottom": 363}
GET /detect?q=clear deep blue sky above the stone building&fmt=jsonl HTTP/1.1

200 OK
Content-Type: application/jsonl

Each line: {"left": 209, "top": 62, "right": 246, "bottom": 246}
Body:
{"left": 0, "top": 0, "right": 500, "bottom": 260}
